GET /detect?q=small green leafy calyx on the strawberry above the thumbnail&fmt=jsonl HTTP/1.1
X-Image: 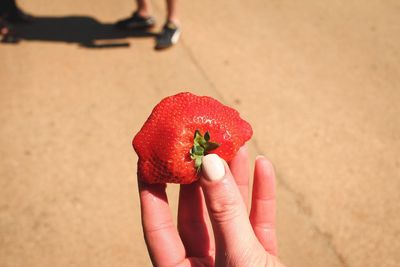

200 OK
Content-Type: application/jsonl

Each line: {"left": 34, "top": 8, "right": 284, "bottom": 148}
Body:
{"left": 190, "top": 130, "right": 220, "bottom": 172}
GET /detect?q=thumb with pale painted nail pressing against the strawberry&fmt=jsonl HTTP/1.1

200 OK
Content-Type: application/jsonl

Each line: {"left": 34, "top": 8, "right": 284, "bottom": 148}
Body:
{"left": 200, "top": 154, "right": 256, "bottom": 253}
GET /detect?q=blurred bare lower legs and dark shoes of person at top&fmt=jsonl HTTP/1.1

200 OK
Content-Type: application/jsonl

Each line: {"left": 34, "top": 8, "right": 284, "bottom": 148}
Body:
{"left": 116, "top": 0, "right": 181, "bottom": 49}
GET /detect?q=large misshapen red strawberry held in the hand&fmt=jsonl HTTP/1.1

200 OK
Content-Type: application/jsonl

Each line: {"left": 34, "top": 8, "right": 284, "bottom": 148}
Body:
{"left": 132, "top": 93, "right": 253, "bottom": 184}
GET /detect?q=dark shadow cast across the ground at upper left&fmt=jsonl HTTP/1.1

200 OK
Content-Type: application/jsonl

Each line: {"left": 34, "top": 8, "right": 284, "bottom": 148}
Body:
{"left": 3, "top": 16, "right": 156, "bottom": 48}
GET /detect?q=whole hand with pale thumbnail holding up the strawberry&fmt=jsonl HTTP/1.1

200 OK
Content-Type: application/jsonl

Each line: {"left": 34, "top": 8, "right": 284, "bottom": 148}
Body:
{"left": 139, "top": 147, "right": 283, "bottom": 266}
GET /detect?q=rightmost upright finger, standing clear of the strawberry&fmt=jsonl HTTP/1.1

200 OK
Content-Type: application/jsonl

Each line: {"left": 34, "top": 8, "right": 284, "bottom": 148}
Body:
{"left": 250, "top": 156, "right": 277, "bottom": 256}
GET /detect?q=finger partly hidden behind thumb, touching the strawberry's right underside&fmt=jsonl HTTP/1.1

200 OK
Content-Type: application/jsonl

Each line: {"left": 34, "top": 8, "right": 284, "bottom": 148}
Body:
{"left": 229, "top": 145, "right": 250, "bottom": 208}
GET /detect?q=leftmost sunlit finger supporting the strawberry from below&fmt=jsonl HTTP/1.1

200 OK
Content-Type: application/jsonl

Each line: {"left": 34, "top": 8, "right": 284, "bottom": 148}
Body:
{"left": 138, "top": 181, "right": 185, "bottom": 266}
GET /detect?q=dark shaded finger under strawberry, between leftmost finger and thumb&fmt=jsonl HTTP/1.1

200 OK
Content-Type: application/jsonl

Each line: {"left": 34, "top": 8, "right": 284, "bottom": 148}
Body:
{"left": 178, "top": 182, "right": 214, "bottom": 258}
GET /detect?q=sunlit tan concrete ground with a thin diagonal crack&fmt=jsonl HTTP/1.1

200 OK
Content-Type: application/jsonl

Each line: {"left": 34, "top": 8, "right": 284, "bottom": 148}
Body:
{"left": 0, "top": 0, "right": 400, "bottom": 267}
